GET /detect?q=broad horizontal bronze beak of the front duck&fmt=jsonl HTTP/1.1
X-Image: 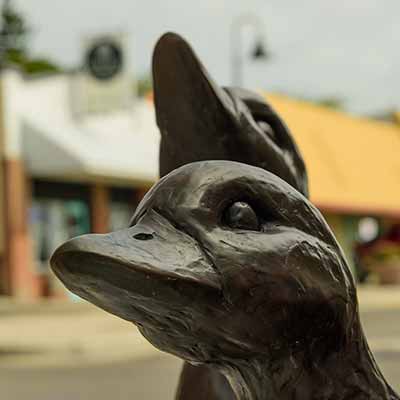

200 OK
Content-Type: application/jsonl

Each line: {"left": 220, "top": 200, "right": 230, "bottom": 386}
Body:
{"left": 50, "top": 210, "right": 220, "bottom": 324}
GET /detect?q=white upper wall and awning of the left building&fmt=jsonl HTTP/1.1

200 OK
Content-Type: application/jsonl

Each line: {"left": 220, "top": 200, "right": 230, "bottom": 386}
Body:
{"left": 1, "top": 70, "right": 159, "bottom": 183}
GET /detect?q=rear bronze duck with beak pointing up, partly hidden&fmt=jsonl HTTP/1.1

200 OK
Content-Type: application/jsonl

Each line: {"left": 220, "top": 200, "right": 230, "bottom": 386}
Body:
{"left": 153, "top": 32, "right": 308, "bottom": 400}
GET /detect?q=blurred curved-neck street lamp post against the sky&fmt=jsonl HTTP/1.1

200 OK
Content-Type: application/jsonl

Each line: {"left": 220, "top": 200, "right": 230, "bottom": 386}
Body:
{"left": 230, "top": 14, "right": 269, "bottom": 86}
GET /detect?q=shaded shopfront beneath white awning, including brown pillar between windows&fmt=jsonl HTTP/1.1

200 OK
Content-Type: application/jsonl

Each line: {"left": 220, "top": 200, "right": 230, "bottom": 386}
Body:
{"left": 28, "top": 179, "right": 143, "bottom": 297}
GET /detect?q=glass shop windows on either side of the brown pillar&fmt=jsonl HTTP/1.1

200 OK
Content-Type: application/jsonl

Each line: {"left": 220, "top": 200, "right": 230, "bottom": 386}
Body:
{"left": 29, "top": 180, "right": 137, "bottom": 294}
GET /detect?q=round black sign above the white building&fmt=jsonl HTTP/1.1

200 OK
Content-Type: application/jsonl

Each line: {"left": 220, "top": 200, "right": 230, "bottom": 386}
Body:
{"left": 87, "top": 41, "right": 123, "bottom": 80}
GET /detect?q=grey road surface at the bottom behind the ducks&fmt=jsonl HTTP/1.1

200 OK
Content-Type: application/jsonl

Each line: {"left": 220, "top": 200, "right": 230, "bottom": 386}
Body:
{"left": 0, "top": 310, "right": 400, "bottom": 400}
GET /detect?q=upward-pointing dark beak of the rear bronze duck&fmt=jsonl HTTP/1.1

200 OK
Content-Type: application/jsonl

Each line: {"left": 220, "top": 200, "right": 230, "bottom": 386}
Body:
{"left": 153, "top": 33, "right": 237, "bottom": 176}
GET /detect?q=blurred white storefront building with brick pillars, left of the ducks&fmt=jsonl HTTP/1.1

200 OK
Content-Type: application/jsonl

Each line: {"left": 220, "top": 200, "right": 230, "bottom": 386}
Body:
{"left": 0, "top": 66, "right": 159, "bottom": 298}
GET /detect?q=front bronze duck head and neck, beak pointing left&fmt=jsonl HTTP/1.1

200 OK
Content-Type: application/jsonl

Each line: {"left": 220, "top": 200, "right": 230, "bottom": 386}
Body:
{"left": 51, "top": 161, "right": 399, "bottom": 400}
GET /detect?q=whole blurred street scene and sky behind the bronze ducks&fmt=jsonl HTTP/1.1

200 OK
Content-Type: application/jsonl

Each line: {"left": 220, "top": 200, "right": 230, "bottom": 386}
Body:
{"left": 0, "top": 0, "right": 400, "bottom": 400}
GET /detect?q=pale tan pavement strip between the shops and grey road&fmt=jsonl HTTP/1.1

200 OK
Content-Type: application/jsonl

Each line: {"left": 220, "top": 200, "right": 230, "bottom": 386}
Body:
{"left": 0, "top": 286, "right": 400, "bottom": 368}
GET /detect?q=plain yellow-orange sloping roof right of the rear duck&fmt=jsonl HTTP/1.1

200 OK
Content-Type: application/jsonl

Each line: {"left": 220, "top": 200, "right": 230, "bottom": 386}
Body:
{"left": 266, "top": 94, "right": 400, "bottom": 217}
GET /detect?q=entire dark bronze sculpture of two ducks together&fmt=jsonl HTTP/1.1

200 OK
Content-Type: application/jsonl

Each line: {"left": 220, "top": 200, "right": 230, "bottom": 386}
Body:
{"left": 52, "top": 34, "right": 397, "bottom": 400}
